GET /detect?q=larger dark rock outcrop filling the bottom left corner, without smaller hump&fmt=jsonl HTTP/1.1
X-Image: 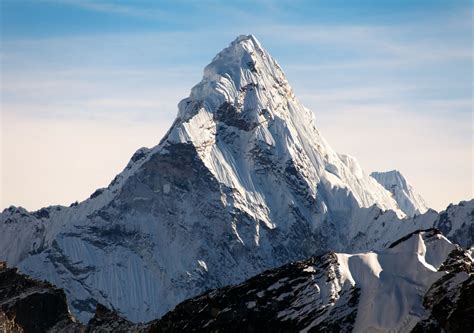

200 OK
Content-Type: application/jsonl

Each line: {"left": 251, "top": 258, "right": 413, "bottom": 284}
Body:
{"left": 0, "top": 267, "right": 80, "bottom": 332}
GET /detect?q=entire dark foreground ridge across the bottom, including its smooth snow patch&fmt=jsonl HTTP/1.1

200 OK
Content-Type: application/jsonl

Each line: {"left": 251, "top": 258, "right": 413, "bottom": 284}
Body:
{"left": 0, "top": 229, "right": 474, "bottom": 332}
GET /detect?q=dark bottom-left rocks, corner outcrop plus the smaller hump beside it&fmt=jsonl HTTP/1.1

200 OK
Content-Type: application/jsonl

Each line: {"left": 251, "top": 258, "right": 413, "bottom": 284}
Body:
{"left": 0, "top": 262, "right": 147, "bottom": 333}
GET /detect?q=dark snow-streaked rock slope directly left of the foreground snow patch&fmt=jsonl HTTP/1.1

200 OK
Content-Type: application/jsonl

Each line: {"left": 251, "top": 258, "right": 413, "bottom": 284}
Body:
{"left": 149, "top": 253, "right": 359, "bottom": 332}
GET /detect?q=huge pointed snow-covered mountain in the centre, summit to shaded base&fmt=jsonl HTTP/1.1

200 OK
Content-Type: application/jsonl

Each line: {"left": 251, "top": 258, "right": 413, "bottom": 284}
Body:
{"left": 0, "top": 36, "right": 472, "bottom": 321}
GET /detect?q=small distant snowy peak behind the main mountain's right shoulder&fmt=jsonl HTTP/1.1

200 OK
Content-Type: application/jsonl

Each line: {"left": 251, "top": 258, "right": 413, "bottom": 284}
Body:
{"left": 370, "top": 170, "right": 428, "bottom": 216}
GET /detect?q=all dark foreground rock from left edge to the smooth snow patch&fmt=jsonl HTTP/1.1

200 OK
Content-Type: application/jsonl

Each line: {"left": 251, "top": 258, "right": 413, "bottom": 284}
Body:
{"left": 0, "top": 253, "right": 359, "bottom": 332}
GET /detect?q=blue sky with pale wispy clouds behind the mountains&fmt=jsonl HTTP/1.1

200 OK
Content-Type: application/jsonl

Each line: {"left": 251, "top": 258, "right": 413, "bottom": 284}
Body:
{"left": 0, "top": 0, "right": 473, "bottom": 209}
